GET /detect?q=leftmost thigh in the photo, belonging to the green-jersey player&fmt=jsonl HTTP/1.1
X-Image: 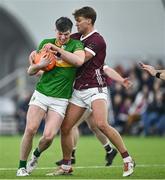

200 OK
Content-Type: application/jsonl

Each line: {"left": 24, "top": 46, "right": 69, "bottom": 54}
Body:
{"left": 26, "top": 105, "right": 45, "bottom": 129}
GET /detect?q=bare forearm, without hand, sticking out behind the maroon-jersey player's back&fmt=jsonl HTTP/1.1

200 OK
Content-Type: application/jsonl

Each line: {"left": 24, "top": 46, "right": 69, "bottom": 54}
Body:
{"left": 103, "top": 65, "right": 124, "bottom": 84}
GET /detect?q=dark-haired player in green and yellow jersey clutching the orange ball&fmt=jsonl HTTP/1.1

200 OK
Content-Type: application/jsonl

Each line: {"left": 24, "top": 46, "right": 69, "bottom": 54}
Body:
{"left": 16, "top": 17, "right": 85, "bottom": 176}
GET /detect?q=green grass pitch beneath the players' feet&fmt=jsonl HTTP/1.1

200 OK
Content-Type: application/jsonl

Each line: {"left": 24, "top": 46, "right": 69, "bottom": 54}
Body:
{"left": 0, "top": 136, "right": 165, "bottom": 179}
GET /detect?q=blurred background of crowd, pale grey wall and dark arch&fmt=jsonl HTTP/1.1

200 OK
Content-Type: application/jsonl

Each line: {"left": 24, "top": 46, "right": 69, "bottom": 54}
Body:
{"left": 0, "top": 0, "right": 165, "bottom": 136}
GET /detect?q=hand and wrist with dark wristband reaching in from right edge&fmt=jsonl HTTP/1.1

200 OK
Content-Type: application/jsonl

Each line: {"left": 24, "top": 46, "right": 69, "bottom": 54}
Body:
{"left": 139, "top": 62, "right": 165, "bottom": 80}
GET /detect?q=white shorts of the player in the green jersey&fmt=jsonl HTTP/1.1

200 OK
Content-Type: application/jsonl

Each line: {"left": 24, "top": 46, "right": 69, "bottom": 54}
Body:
{"left": 29, "top": 90, "right": 68, "bottom": 117}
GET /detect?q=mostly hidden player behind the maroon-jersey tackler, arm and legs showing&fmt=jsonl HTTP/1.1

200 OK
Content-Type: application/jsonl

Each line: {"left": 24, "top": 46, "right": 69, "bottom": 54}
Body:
{"left": 56, "top": 65, "right": 133, "bottom": 166}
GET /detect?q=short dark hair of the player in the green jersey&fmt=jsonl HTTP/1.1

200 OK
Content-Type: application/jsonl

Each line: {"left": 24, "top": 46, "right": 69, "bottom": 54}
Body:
{"left": 55, "top": 17, "right": 73, "bottom": 32}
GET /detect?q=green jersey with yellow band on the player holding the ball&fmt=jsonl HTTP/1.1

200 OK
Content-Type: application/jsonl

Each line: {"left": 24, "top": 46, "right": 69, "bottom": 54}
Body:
{"left": 36, "top": 38, "right": 84, "bottom": 99}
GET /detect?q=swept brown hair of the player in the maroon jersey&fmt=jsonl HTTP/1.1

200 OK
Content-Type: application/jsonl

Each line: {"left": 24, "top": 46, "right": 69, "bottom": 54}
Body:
{"left": 73, "top": 6, "right": 97, "bottom": 25}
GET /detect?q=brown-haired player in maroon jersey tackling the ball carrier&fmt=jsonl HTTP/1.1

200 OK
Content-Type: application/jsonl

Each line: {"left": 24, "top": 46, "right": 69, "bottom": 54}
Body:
{"left": 46, "top": 7, "right": 135, "bottom": 176}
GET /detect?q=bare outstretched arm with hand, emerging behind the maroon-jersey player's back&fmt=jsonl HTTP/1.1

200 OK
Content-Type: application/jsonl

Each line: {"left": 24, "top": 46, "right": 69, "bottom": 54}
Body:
{"left": 103, "top": 65, "right": 133, "bottom": 89}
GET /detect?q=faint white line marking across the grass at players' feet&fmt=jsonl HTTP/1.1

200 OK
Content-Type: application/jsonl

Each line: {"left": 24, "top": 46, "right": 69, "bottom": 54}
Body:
{"left": 0, "top": 164, "right": 165, "bottom": 171}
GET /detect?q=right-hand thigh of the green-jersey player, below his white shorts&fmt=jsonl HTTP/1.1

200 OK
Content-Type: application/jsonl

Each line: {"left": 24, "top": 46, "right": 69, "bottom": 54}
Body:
{"left": 43, "top": 110, "right": 63, "bottom": 138}
